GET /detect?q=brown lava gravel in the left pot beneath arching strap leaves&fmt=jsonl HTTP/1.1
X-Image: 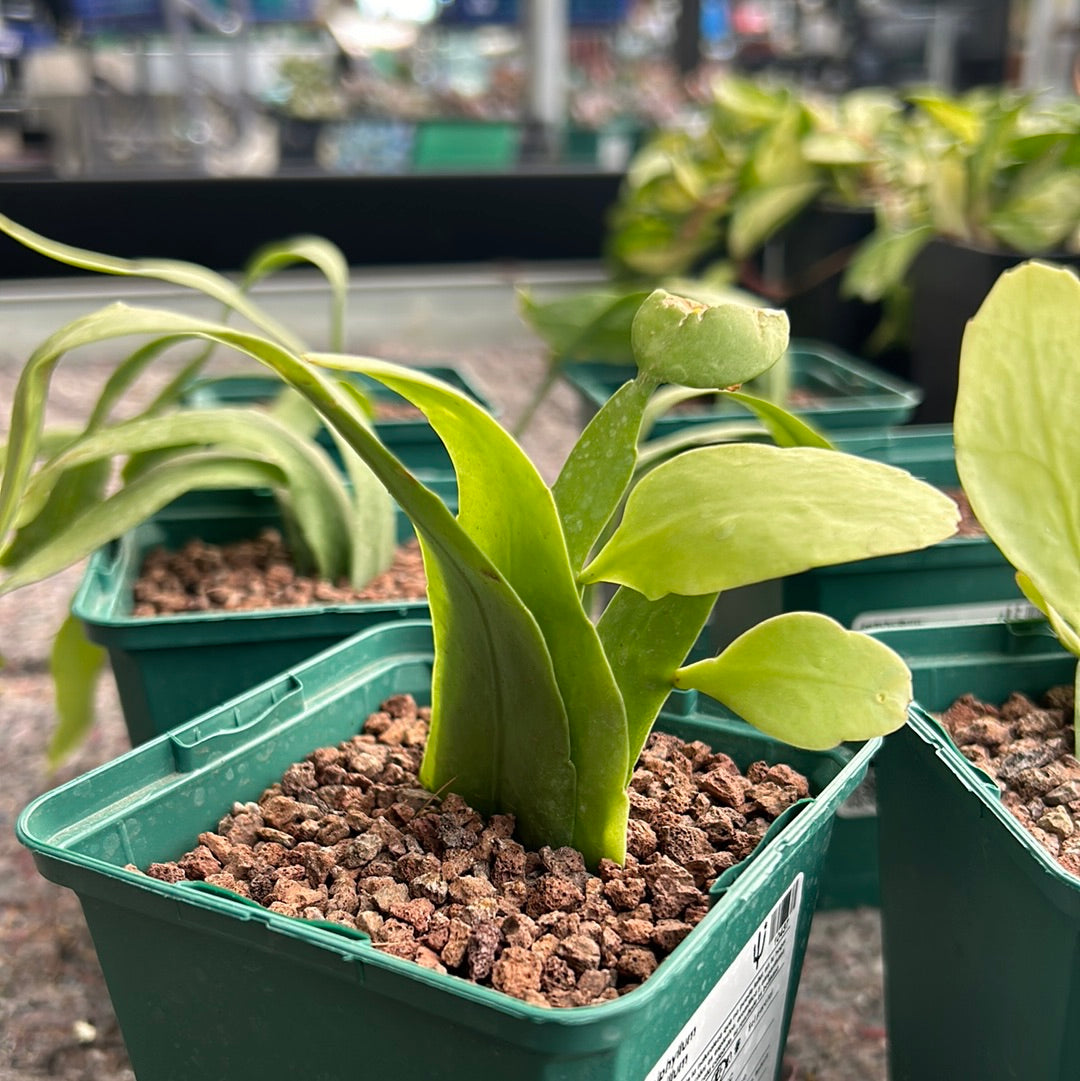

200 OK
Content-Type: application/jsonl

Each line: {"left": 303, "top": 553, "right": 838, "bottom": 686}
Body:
{"left": 133, "top": 529, "right": 427, "bottom": 616}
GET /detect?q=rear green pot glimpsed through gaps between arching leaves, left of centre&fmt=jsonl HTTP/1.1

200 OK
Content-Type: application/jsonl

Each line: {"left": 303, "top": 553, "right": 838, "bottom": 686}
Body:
{"left": 184, "top": 365, "right": 494, "bottom": 476}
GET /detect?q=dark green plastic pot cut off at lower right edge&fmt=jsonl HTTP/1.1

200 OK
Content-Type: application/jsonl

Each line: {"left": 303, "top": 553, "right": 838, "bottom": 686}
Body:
{"left": 876, "top": 622, "right": 1080, "bottom": 1081}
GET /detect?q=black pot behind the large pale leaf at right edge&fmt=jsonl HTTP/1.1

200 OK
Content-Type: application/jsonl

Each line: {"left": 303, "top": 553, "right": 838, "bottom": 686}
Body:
{"left": 908, "top": 238, "right": 1080, "bottom": 424}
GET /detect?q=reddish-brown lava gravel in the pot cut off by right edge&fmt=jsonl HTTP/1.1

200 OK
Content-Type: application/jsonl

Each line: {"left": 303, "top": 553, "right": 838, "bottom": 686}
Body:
{"left": 942, "top": 684, "right": 1080, "bottom": 876}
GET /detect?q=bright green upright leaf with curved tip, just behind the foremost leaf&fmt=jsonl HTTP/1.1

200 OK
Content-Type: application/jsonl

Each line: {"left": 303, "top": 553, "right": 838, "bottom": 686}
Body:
{"left": 311, "top": 355, "right": 627, "bottom": 862}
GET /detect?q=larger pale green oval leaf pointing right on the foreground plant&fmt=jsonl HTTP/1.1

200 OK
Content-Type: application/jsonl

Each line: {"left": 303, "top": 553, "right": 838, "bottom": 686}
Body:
{"left": 579, "top": 443, "right": 958, "bottom": 599}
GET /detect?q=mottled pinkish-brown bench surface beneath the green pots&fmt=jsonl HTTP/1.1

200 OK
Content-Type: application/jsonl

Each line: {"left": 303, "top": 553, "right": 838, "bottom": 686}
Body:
{"left": 0, "top": 315, "right": 885, "bottom": 1081}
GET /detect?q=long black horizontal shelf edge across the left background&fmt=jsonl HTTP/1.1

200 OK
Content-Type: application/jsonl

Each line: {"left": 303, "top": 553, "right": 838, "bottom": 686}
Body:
{"left": 0, "top": 170, "right": 622, "bottom": 279}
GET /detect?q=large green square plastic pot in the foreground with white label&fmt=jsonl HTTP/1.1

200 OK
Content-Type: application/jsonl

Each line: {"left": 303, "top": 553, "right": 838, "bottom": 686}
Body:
{"left": 17, "top": 620, "right": 877, "bottom": 1081}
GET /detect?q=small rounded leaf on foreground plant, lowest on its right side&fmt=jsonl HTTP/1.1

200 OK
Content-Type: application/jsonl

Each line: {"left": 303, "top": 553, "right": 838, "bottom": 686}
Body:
{"left": 675, "top": 612, "right": 911, "bottom": 750}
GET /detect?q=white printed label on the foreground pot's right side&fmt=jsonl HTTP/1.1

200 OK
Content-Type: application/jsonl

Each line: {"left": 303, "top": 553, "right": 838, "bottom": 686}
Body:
{"left": 645, "top": 872, "right": 803, "bottom": 1081}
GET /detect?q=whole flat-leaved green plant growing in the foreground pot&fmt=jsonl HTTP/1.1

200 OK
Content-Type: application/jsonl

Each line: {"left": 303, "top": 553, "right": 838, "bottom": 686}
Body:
{"left": 0, "top": 215, "right": 957, "bottom": 864}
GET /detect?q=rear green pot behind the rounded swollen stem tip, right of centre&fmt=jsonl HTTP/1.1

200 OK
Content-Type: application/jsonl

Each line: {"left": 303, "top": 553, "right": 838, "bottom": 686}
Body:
{"left": 562, "top": 339, "right": 921, "bottom": 438}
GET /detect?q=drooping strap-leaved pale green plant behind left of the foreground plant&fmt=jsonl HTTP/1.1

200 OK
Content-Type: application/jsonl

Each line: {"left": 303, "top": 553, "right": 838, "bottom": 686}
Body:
{"left": 0, "top": 218, "right": 394, "bottom": 763}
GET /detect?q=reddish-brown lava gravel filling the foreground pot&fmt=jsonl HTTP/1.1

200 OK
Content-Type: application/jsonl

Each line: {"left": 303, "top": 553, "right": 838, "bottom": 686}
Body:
{"left": 139, "top": 695, "right": 808, "bottom": 1006}
